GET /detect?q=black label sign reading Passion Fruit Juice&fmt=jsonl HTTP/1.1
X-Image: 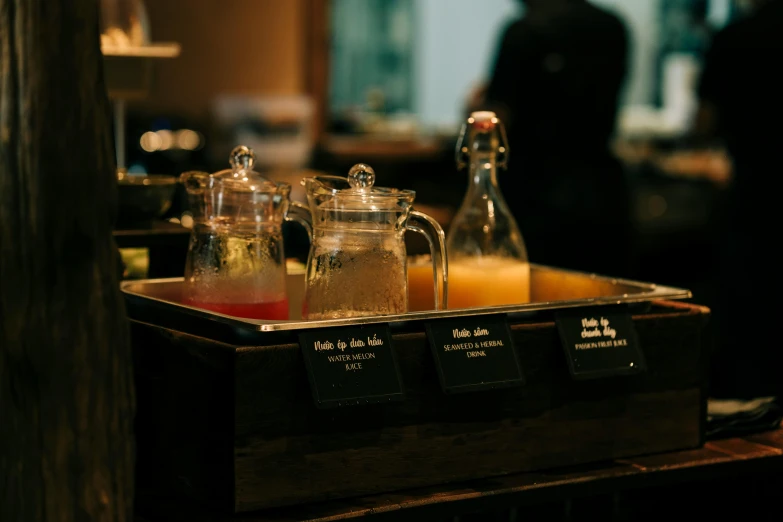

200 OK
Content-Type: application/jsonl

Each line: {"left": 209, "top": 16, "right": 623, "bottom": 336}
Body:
{"left": 555, "top": 306, "right": 647, "bottom": 379}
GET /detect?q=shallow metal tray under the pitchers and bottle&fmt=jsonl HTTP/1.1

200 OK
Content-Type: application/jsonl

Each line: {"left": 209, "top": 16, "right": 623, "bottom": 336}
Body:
{"left": 121, "top": 265, "right": 692, "bottom": 338}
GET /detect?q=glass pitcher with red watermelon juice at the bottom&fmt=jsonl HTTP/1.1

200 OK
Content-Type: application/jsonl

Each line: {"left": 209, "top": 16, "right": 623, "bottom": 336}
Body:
{"left": 180, "top": 146, "right": 309, "bottom": 320}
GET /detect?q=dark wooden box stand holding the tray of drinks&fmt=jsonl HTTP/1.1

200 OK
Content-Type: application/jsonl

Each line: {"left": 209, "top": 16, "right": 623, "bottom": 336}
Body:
{"left": 132, "top": 302, "right": 709, "bottom": 512}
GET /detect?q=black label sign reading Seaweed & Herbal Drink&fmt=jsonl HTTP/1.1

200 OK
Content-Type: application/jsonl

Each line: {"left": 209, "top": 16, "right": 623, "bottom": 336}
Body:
{"left": 427, "top": 316, "right": 524, "bottom": 393}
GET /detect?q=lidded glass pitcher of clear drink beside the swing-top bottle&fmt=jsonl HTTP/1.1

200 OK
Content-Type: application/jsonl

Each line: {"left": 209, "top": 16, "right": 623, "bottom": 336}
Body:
{"left": 302, "top": 164, "right": 448, "bottom": 320}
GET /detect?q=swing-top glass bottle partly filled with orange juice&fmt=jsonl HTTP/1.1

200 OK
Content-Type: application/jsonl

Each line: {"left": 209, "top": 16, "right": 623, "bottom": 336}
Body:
{"left": 446, "top": 111, "right": 530, "bottom": 309}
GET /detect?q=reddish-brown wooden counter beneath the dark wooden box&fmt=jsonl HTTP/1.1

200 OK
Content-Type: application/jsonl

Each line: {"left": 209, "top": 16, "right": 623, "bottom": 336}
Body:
{"left": 136, "top": 422, "right": 783, "bottom": 522}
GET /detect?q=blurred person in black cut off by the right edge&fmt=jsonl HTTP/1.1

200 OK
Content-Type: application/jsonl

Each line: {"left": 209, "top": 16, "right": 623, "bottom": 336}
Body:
{"left": 695, "top": 0, "right": 783, "bottom": 399}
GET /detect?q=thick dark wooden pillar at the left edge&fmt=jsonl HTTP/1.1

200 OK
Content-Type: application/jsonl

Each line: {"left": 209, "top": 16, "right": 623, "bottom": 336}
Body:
{"left": 0, "top": 0, "right": 134, "bottom": 522}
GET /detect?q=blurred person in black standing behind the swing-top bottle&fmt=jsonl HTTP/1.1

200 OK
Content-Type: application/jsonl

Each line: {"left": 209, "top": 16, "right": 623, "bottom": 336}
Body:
{"left": 469, "top": 0, "right": 631, "bottom": 276}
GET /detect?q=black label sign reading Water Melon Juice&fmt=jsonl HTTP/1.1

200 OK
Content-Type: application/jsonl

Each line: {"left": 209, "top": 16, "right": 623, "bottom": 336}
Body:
{"left": 299, "top": 325, "right": 404, "bottom": 408}
